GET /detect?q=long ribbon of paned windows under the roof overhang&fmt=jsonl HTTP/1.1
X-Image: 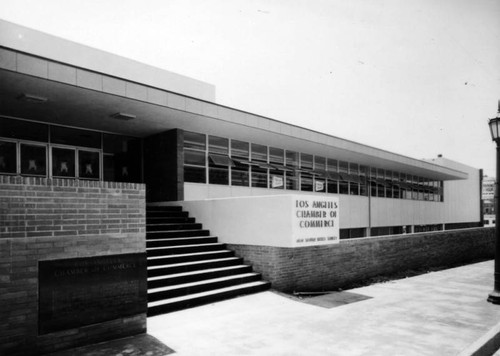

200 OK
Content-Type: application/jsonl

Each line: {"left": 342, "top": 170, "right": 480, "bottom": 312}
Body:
{"left": 178, "top": 132, "right": 443, "bottom": 201}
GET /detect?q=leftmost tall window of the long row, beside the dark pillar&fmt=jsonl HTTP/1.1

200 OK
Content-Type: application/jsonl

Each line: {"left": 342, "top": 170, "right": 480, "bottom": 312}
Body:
{"left": 184, "top": 131, "right": 207, "bottom": 183}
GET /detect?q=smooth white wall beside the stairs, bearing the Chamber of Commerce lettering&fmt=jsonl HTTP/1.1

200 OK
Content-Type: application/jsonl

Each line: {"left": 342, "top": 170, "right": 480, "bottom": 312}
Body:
{"left": 160, "top": 195, "right": 341, "bottom": 247}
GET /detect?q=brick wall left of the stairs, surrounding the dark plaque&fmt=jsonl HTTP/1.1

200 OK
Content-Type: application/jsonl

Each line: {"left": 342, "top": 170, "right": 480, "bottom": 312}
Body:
{"left": 0, "top": 176, "right": 146, "bottom": 355}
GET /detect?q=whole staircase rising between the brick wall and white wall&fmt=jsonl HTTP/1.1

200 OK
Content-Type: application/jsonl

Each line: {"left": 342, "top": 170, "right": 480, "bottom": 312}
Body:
{"left": 146, "top": 206, "right": 270, "bottom": 316}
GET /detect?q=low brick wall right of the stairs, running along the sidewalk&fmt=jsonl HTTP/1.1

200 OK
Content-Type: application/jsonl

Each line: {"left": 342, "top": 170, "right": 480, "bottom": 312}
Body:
{"left": 228, "top": 228, "right": 494, "bottom": 292}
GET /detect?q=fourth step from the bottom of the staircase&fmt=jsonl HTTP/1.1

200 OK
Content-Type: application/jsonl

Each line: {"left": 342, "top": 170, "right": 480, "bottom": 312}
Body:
{"left": 148, "top": 257, "right": 243, "bottom": 277}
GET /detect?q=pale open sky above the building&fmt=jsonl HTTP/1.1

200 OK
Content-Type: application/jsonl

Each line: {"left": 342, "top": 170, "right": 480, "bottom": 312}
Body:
{"left": 0, "top": 0, "right": 500, "bottom": 176}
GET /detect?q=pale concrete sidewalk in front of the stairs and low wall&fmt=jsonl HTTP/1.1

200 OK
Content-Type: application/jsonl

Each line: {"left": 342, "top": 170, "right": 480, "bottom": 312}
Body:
{"left": 148, "top": 261, "right": 500, "bottom": 356}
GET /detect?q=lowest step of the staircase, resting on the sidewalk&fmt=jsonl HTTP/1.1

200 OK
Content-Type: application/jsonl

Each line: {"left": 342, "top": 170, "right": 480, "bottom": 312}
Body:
{"left": 148, "top": 281, "right": 270, "bottom": 316}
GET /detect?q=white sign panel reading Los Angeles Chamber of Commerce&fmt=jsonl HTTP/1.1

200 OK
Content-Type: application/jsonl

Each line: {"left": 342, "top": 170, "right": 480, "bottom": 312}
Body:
{"left": 292, "top": 196, "right": 340, "bottom": 247}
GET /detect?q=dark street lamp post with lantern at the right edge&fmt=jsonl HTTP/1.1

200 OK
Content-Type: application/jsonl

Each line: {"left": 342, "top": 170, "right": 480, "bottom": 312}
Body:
{"left": 488, "top": 100, "right": 500, "bottom": 304}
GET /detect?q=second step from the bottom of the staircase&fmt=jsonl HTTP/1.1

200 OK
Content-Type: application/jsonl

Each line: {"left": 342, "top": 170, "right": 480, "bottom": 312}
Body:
{"left": 148, "top": 272, "right": 261, "bottom": 302}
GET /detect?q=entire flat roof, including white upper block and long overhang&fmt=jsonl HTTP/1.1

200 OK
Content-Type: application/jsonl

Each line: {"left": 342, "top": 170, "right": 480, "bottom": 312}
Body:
{"left": 0, "top": 20, "right": 468, "bottom": 180}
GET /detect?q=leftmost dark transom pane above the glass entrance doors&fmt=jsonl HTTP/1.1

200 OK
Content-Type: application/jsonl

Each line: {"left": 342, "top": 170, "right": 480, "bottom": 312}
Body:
{"left": 0, "top": 117, "right": 49, "bottom": 142}
